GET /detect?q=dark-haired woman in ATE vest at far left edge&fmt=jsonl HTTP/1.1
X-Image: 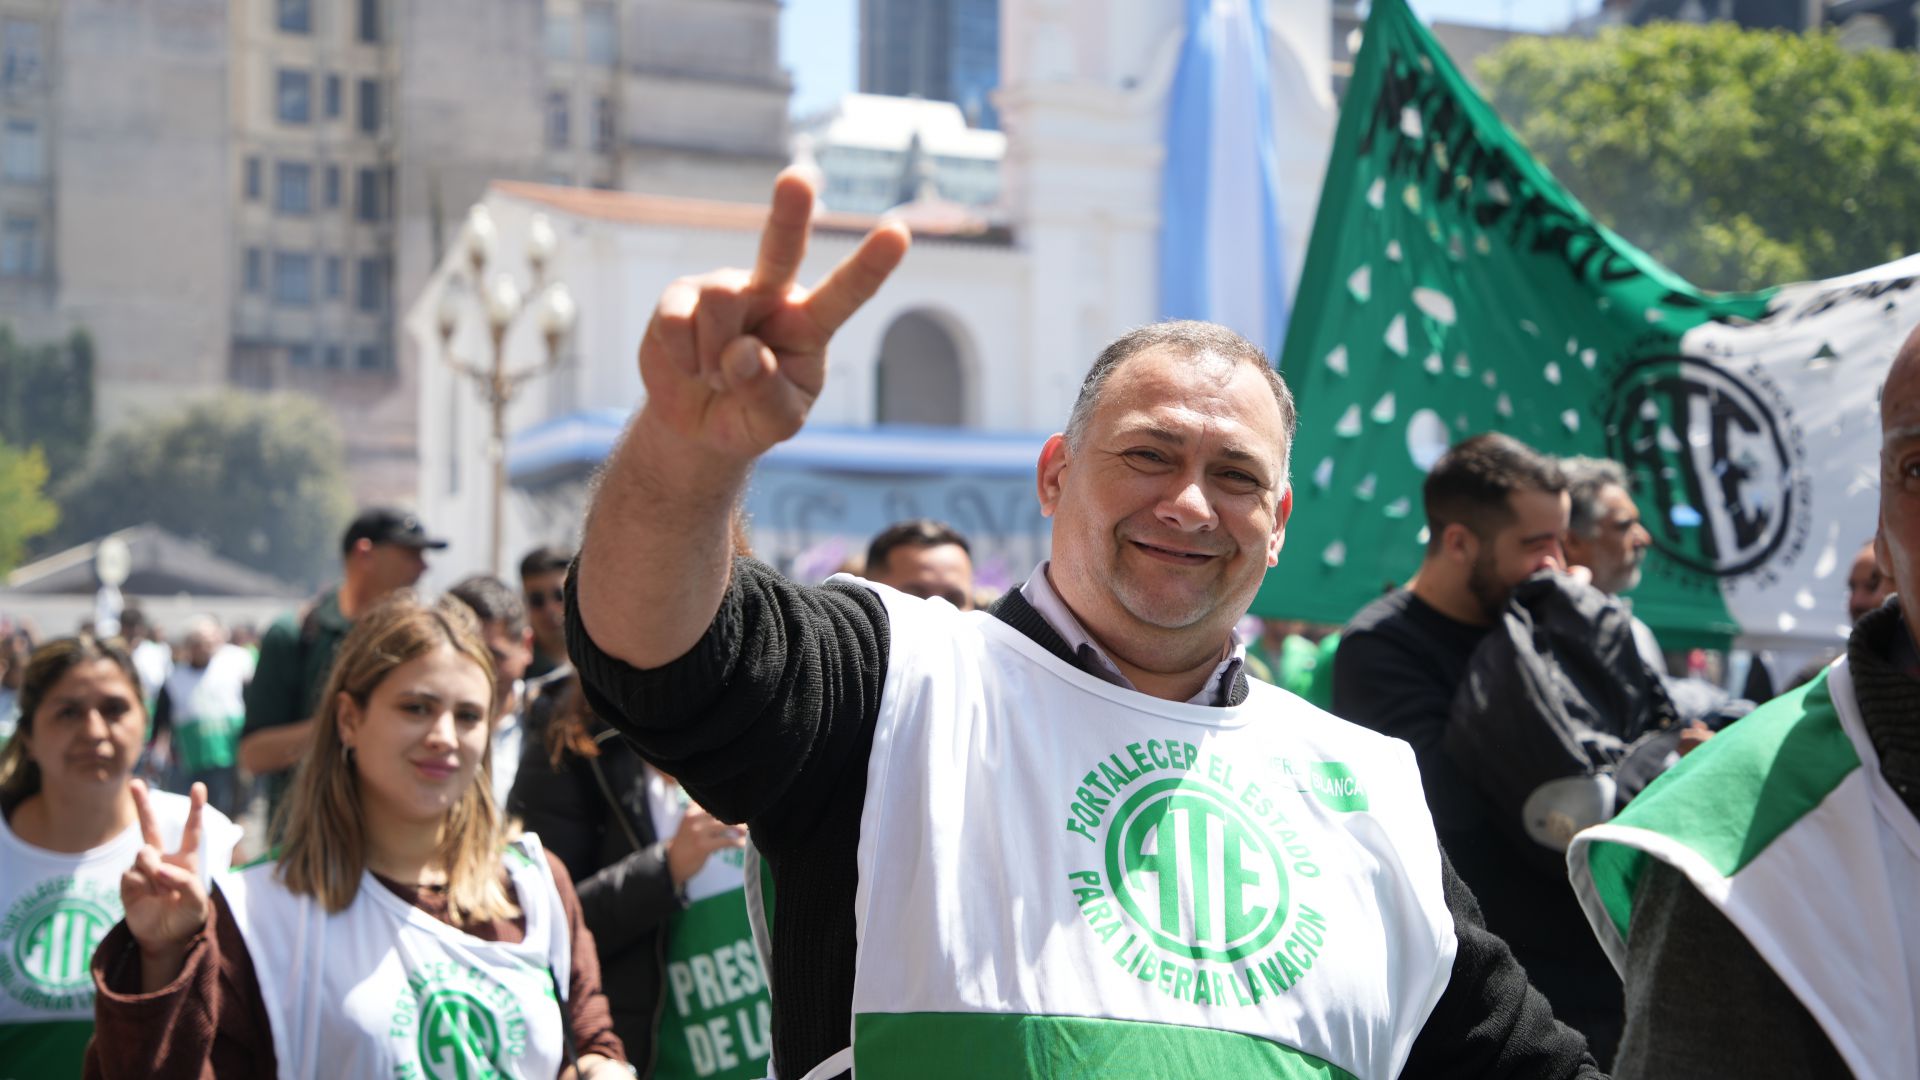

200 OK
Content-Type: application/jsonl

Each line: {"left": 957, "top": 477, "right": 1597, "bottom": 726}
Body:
{"left": 0, "top": 638, "right": 240, "bottom": 1076}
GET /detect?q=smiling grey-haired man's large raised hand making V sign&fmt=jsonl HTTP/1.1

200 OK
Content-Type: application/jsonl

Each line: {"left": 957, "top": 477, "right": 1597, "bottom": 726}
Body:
{"left": 639, "top": 173, "right": 910, "bottom": 463}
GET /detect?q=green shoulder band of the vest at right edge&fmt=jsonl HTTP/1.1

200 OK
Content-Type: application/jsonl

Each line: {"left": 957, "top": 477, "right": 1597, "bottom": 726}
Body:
{"left": 1588, "top": 673, "right": 1860, "bottom": 940}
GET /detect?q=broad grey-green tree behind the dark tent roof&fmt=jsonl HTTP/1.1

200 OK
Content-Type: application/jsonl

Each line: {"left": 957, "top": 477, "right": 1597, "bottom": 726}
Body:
{"left": 56, "top": 392, "right": 353, "bottom": 584}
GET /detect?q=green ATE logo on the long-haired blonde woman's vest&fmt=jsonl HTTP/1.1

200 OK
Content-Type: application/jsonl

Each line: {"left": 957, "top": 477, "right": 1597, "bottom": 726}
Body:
{"left": 388, "top": 961, "right": 537, "bottom": 1080}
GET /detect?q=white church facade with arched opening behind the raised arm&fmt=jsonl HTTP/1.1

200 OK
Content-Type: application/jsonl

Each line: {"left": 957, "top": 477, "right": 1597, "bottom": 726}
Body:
{"left": 407, "top": 0, "right": 1334, "bottom": 586}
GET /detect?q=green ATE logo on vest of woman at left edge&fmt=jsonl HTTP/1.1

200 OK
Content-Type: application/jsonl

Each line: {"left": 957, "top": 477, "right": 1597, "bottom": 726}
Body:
{"left": 0, "top": 876, "right": 121, "bottom": 1013}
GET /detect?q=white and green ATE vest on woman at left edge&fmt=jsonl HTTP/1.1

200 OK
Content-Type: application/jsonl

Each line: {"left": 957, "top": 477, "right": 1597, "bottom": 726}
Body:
{"left": 0, "top": 792, "right": 240, "bottom": 1080}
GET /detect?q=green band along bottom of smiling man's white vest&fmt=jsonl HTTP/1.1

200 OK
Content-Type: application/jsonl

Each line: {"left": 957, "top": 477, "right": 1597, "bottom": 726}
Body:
{"left": 852, "top": 1013, "right": 1354, "bottom": 1080}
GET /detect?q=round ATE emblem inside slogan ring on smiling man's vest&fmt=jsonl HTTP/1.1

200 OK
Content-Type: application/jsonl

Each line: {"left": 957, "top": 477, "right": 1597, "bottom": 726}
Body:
{"left": 1106, "top": 778, "right": 1286, "bottom": 963}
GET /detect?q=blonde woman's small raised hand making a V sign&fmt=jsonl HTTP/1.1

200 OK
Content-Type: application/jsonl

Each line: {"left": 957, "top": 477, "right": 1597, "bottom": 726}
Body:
{"left": 121, "top": 780, "right": 211, "bottom": 992}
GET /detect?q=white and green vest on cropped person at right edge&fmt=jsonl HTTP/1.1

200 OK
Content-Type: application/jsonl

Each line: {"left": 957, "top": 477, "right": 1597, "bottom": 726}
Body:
{"left": 1567, "top": 659, "right": 1920, "bottom": 1078}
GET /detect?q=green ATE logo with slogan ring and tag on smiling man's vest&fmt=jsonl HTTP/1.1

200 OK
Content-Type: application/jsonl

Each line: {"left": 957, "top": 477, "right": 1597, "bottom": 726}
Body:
{"left": 1066, "top": 740, "right": 1367, "bottom": 1007}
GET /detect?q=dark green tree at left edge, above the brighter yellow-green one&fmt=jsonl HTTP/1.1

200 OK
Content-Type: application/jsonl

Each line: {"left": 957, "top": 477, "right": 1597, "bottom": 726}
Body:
{"left": 0, "top": 327, "right": 94, "bottom": 484}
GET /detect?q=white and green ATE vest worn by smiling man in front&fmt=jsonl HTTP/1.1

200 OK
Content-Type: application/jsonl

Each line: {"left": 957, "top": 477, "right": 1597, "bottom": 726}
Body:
{"left": 816, "top": 588, "right": 1457, "bottom": 1080}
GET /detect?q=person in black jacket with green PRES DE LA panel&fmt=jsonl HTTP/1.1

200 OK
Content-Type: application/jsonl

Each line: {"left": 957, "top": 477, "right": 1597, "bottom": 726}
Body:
{"left": 509, "top": 676, "right": 772, "bottom": 1080}
